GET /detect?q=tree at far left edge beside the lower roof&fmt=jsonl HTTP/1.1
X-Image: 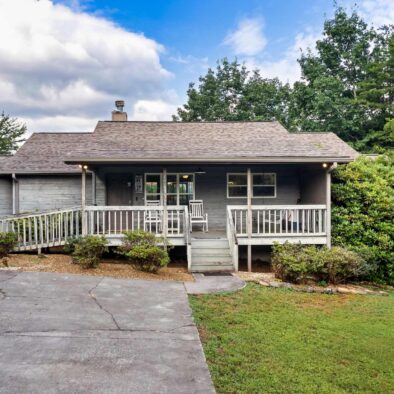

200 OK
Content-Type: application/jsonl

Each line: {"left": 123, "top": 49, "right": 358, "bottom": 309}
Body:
{"left": 0, "top": 113, "right": 26, "bottom": 155}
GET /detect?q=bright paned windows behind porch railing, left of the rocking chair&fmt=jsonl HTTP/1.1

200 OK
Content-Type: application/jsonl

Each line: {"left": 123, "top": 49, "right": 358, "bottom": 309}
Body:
{"left": 145, "top": 173, "right": 194, "bottom": 205}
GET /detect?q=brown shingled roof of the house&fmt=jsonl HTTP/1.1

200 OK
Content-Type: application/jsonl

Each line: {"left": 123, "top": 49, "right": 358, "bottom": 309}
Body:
{"left": 0, "top": 121, "right": 357, "bottom": 173}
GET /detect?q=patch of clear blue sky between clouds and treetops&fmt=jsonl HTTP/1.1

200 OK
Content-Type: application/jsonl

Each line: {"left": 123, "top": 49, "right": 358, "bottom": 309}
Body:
{"left": 71, "top": 0, "right": 333, "bottom": 99}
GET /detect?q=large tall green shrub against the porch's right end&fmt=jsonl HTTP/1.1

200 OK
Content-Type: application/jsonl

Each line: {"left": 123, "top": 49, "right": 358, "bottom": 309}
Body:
{"left": 332, "top": 151, "right": 394, "bottom": 285}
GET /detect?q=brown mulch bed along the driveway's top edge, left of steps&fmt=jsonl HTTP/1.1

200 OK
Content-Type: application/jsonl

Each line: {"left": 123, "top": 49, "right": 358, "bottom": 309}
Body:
{"left": 0, "top": 254, "right": 194, "bottom": 282}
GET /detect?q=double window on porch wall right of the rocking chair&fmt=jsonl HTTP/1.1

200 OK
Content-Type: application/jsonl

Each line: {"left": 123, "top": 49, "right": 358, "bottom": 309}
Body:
{"left": 227, "top": 173, "right": 276, "bottom": 198}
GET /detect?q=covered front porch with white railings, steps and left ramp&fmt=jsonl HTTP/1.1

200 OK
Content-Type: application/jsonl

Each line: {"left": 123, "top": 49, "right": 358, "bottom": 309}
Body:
{"left": 0, "top": 163, "right": 330, "bottom": 271}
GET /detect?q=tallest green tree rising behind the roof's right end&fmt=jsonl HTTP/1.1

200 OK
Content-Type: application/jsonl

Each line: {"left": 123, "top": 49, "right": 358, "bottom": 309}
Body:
{"left": 293, "top": 8, "right": 390, "bottom": 143}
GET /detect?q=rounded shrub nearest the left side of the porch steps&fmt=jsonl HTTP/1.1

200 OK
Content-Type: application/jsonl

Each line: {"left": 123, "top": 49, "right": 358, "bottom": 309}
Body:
{"left": 118, "top": 230, "right": 170, "bottom": 273}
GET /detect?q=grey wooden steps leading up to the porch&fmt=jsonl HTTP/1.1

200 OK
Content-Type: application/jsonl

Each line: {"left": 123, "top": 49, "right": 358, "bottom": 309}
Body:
{"left": 191, "top": 238, "right": 234, "bottom": 272}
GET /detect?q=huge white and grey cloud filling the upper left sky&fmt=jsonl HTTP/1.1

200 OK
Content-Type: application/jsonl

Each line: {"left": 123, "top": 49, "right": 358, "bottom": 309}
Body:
{"left": 0, "top": 0, "right": 172, "bottom": 131}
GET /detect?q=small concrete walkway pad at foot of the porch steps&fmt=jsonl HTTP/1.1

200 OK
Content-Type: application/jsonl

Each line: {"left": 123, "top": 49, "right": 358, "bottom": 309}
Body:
{"left": 185, "top": 274, "right": 245, "bottom": 294}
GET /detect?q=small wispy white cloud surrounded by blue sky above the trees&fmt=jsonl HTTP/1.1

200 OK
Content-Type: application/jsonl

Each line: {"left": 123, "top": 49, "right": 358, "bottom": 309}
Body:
{"left": 224, "top": 18, "right": 267, "bottom": 56}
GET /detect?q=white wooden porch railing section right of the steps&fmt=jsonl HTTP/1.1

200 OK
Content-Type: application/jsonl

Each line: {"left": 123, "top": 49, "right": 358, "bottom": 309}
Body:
{"left": 228, "top": 205, "right": 327, "bottom": 237}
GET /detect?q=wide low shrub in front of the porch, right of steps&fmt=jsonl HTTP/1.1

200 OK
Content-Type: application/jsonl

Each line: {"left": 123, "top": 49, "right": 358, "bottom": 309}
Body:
{"left": 272, "top": 243, "right": 373, "bottom": 284}
